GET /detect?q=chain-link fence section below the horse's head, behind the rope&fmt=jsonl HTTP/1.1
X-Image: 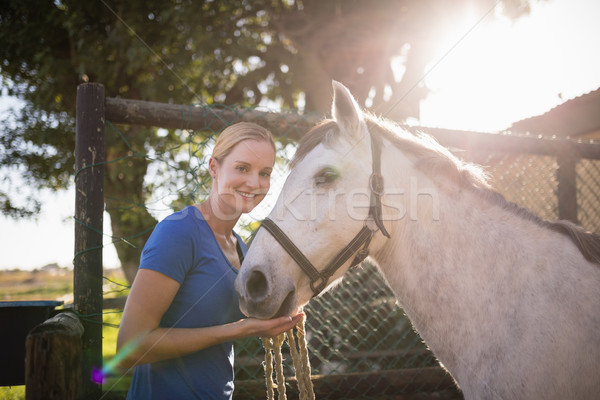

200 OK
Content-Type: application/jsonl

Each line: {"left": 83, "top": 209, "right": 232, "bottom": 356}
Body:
{"left": 235, "top": 263, "right": 460, "bottom": 399}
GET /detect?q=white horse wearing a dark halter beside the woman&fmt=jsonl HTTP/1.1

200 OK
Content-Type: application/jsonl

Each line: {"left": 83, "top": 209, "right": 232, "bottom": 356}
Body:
{"left": 236, "top": 82, "right": 600, "bottom": 400}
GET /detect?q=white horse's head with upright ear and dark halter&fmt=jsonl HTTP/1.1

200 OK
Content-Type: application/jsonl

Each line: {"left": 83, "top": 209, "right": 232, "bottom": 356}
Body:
{"left": 236, "top": 81, "right": 396, "bottom": 318}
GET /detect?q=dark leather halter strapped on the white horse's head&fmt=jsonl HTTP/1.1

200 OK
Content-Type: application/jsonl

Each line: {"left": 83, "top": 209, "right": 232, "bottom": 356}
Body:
{"left": 261, "top": 130, "right": 390, "bottom": 297}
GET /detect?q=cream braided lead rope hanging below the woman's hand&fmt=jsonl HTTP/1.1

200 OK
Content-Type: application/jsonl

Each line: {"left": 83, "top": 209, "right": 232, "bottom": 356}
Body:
{"left": 261, "top": 317, "right": 315, "bottom": 400}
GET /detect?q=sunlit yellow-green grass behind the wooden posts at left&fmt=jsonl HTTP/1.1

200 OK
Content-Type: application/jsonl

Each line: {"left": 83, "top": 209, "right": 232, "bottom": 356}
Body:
{"left": 0, "top": 268, "right": 131, "bottom": 400}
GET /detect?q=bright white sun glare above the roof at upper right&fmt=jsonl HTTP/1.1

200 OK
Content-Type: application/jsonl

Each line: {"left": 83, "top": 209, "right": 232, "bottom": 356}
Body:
{"left": 421, "top": 0, "right": 600, "bottom": 131}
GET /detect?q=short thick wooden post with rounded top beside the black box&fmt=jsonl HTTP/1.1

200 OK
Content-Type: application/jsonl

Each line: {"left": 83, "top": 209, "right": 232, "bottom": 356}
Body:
{"left": 25, "top": 312, "right": 83, "bottom": 400}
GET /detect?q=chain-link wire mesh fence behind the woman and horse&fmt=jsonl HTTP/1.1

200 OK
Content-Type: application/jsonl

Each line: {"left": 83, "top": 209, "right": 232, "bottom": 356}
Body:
{"left": 89, "top": 97, "right": 600, "bottom": 399}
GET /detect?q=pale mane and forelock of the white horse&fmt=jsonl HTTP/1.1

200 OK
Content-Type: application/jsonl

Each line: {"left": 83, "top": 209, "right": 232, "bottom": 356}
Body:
{"left": 290, "top": 113, "right": 600, "bottom": 265}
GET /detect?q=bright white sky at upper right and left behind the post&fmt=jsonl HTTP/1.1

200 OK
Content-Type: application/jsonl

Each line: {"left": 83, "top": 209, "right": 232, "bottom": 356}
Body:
{"left": 0, "top": 0, "right": 600, "bottom": 270}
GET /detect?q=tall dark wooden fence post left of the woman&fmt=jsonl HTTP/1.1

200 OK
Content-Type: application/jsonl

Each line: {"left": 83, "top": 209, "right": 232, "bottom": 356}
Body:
{"left": 73, "top": 83, "right": 105, "bottom": 399}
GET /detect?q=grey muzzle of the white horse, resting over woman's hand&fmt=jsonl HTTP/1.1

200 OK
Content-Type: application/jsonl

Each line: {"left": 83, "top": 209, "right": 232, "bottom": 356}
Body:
{"left": 235, "top": 266, "right": 298, "bottom": 319}
